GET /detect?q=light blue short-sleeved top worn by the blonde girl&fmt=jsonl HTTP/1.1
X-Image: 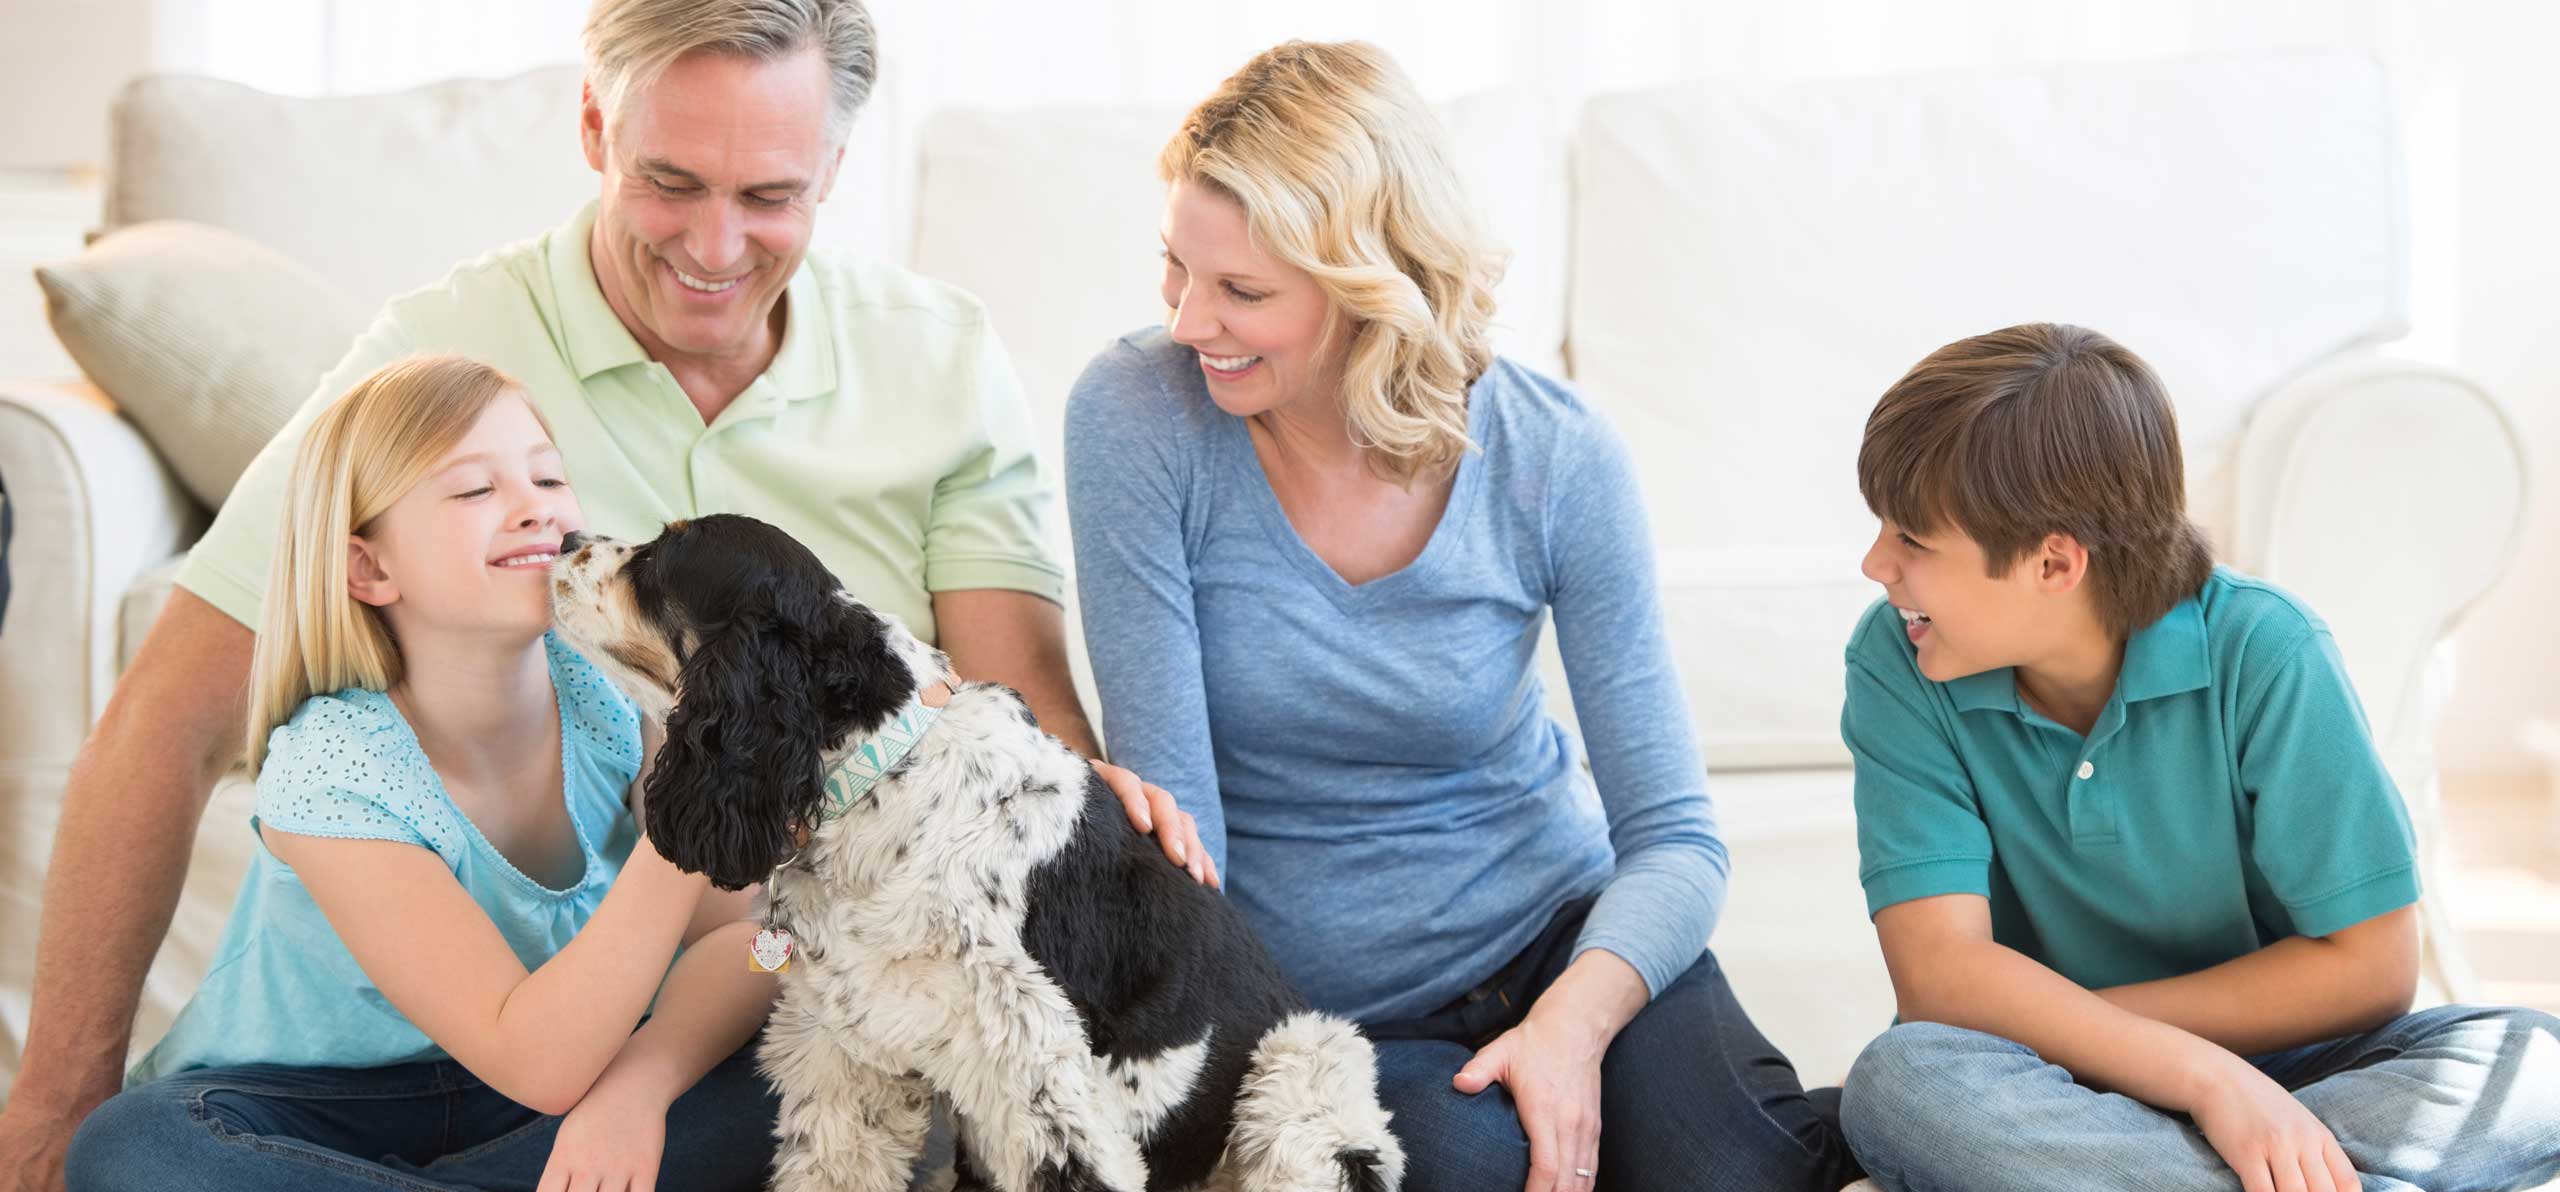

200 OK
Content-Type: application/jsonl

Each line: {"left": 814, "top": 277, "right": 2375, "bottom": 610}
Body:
{"left": 125, "top": 634, "right": 640, "bottom": 1087}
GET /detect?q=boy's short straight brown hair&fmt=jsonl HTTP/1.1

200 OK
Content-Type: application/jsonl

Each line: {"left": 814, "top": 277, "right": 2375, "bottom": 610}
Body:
{"left": 1859, "top": 322, "right": 2214, "bottom": 637}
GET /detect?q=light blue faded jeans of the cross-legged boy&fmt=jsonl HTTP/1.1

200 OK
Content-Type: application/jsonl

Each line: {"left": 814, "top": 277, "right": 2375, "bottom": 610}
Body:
{"left": 1841, "top": 1005, "right": 2560, "bottom": 1192}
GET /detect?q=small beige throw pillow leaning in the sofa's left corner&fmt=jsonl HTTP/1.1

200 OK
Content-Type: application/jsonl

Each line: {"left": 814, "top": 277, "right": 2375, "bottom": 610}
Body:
{"left": 36, "top": 220, "right": 366, "bottom": 509}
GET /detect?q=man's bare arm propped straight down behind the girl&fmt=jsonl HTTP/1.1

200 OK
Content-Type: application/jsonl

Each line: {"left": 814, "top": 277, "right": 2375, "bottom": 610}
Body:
{"left": 0, "top": 588, "right": 256, "bottom": 1189}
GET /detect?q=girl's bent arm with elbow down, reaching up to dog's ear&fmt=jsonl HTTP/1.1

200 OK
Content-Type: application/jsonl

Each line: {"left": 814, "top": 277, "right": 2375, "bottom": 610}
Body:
{"left": 264, "top": 829, "right": 706, "bottom": 1113}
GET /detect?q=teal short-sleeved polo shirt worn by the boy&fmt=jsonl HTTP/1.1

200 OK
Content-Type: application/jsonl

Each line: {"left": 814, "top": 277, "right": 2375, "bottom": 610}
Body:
{"left": 1841, "top": 568, "right": 2419, "bottom": 990}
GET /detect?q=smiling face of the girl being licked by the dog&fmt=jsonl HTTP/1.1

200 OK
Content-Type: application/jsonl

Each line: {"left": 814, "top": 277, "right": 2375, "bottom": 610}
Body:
{"left": 348, "top": 394, "right": 586, "bottom": 637}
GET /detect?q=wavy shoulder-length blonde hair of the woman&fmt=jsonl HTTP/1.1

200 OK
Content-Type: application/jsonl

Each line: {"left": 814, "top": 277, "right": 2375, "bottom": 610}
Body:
{"left": 1157, "top": 41, "right": 1503, "bottom": 481}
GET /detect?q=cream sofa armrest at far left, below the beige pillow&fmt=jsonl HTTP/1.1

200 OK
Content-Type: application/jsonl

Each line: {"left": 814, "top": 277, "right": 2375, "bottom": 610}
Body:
{"left": 0, "top": 379, "right": 207, "bottom": 772}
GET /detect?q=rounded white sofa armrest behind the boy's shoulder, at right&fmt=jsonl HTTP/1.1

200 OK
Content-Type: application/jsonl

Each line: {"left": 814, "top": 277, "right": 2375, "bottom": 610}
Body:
{"left": 2232, "top": 356, "right": 2532, "bottom": 1000}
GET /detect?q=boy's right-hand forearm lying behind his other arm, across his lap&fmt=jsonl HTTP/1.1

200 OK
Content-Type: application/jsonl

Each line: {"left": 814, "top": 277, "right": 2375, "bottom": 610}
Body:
{"left": 2097, "top": 906, "right": 2419, "bottom": 1056}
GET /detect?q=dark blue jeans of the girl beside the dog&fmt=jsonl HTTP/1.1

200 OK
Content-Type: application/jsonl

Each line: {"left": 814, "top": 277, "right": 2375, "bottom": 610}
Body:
{"left": 64, "top": 1044, "right": 781, "bottom": 1192}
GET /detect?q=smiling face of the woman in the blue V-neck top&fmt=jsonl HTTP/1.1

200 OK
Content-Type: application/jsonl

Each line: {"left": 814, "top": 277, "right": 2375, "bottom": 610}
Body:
{"left": 1162, "top": 182, "right": 1349, "bottom": 417}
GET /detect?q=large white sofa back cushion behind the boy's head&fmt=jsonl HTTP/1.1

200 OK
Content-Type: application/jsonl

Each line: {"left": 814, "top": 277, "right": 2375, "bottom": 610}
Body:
{"left": 1569, "top": 54, "right": 2406, "bottom": 765}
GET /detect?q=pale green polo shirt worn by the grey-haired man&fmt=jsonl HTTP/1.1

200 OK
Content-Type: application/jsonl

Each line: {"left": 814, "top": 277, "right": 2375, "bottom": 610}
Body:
{"left": 177, "top": 205, "right": 1062, "bottom": 642}
